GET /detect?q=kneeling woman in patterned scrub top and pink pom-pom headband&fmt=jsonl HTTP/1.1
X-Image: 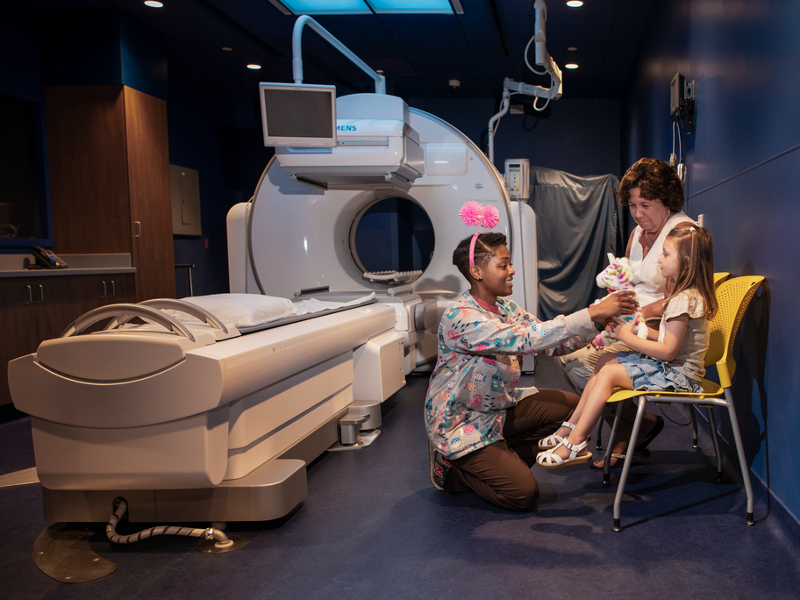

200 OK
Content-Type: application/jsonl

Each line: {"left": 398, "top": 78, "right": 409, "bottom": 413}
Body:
{"left": 425, "top": 233, "right": 634, "bottom": 511}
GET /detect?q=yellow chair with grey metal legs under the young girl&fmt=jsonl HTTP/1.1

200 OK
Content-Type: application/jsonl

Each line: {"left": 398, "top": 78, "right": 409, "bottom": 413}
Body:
{"left": 603, "top": 276, "right": 764, "bottom": 531}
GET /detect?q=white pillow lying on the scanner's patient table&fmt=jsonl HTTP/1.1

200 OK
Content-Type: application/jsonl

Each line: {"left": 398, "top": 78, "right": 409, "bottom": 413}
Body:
{"left": 173, "top": 294, "right": 295, "bottom": 329}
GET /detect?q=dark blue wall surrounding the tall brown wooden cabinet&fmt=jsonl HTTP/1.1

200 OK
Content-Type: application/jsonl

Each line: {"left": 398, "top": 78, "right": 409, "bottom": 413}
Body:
{"left": 0, "top": 5, "right": 272, "bottom": 297}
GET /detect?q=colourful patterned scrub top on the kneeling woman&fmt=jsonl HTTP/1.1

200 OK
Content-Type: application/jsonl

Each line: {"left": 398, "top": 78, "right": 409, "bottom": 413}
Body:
{"left": 425, "top": 291, "right": 597, "bottom": 458}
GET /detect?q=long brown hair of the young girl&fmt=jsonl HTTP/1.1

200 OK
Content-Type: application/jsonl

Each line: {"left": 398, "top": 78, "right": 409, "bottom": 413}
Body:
{"left": 664, "top": 223, "right": 719, "bottom": 319}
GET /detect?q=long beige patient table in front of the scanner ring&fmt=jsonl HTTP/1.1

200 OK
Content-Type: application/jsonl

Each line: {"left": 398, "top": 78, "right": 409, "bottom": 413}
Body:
{"left": 9, "top": 300, "right": 405, "bottom": 522}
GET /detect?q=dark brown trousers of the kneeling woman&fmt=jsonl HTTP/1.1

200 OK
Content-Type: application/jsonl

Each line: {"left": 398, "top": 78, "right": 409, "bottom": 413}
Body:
{"left": 444, "top": 389, "right": 580, "bottom": 511}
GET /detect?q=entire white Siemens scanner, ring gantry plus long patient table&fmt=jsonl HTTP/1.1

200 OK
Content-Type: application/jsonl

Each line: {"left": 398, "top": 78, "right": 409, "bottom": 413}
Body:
{"left": 8, "top": 19, "right": 537, "bottom": 522}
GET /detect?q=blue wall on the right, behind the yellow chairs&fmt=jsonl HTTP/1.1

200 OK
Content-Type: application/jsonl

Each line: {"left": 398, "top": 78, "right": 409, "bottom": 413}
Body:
{"left": 623, "top": 0, "right": 800, "bottom": 519}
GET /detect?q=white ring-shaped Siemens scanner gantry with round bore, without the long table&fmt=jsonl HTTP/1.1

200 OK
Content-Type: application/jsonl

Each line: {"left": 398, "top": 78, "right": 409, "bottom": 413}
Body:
{"left": 228, "top": 94, "right": 538, "bottom": 373}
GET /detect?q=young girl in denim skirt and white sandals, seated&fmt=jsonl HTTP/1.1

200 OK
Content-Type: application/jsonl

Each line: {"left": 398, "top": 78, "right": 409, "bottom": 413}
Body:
{"left": 536, "top": 225, "right": 717, "bottom": 468}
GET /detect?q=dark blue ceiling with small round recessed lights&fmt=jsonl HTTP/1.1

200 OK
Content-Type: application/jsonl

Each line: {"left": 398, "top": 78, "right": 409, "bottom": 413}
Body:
{"left": 23, "top": 0, "right": 654, "bottom": 100}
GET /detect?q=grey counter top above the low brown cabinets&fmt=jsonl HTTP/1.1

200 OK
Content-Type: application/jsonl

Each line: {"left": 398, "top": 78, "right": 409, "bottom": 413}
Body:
{"left": 0, "top": 254, "right": 136, "bottom": 279}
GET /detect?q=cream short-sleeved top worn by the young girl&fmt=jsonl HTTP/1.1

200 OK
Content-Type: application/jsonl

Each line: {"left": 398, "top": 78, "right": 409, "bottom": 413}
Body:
{"left": 658, "top": 288, "right": 709, "bottom": 381}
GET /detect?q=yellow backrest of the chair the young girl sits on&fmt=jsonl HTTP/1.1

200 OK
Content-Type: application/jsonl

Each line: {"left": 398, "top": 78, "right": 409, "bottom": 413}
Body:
{"left": 705, "top": 275, "right": 764, "bottom": 387}
